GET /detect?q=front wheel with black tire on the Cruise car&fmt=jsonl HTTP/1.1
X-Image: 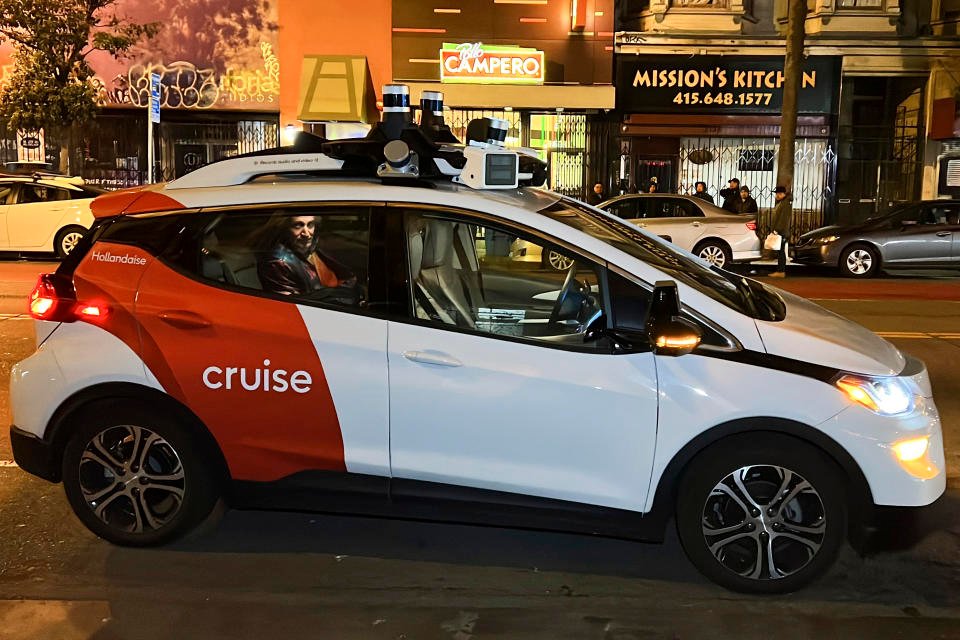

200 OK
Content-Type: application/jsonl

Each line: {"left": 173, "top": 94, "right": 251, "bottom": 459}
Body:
{"left": 677, "top": 434, "right": 847, "bottom": 594}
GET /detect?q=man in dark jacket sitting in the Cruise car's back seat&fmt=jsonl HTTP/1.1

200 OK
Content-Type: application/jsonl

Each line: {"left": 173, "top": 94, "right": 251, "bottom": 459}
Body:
{"left": 257, "top": 212, "right": 362, "bottom": 306}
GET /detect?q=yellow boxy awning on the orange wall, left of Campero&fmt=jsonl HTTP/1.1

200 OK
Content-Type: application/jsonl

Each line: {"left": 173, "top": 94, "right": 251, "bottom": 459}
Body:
{"left": 297, "top": 55, "right": 379, "bottom": 122}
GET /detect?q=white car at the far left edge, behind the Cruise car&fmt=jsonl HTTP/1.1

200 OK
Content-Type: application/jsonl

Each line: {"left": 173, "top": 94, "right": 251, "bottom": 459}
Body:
{"left": 0, "top": 173, "right": 103, "bottom": 258}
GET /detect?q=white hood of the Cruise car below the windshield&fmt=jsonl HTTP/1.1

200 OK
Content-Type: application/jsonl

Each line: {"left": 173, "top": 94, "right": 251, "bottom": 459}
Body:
{"left": 757, "top": 285, "right": 906, "bottom": 376}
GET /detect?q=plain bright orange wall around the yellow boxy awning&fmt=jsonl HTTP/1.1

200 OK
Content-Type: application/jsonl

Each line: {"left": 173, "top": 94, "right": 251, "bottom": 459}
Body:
{"left": 277, "top": 0, "right": 393, "bottom": 127}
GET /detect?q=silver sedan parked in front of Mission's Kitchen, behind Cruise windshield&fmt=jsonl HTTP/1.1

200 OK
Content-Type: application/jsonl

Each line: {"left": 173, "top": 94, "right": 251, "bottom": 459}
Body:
{"left": 597, "top": 193, "right": 760, "bottom": 267}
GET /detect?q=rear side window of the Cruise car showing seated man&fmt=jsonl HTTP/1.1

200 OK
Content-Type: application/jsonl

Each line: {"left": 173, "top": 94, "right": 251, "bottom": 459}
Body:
{"left": 198, "top": 207, "right": 370, "bottom": 307}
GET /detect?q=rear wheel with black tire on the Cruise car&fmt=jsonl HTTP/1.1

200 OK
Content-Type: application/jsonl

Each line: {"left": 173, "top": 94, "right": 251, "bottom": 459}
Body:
{"left": 63, "top": 399, "right": 221, "bottom": 547}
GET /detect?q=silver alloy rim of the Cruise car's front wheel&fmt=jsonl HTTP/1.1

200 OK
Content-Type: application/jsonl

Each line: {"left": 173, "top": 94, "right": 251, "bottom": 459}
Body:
{"left": 701, "top": 465, "right": 827, "bottom": 580}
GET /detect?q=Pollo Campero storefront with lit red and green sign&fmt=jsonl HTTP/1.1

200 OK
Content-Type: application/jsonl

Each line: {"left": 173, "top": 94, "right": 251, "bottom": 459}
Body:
{"left": 392, "top": 0, "right": 615, "bottom": 198}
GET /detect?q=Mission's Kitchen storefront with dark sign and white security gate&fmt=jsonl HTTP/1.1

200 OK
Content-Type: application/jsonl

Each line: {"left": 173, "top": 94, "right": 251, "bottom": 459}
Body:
{"left": 608, "top": 55, "right": 840, "bottom": 229}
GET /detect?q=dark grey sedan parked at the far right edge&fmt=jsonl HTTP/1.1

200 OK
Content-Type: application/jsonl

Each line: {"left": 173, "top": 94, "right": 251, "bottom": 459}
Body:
{"left": 792, "top": 200, "right": 960, "bottom": 278}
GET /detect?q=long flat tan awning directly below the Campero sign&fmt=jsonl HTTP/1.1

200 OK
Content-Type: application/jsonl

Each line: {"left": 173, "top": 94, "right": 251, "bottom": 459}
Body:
{"left": 406, "top": 82, "right": 616, "bottom": 109}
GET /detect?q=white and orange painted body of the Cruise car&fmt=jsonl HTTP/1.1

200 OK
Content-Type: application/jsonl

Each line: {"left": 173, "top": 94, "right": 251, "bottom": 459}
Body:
{"left": 11, "top": 148, "right": 945, "bottom": 592}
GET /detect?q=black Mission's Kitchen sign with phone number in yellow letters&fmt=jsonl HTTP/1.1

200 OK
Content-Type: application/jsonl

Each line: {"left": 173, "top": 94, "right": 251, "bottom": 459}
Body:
{"left": 617, "top": 55, "right": 840, "bottom": 115}
